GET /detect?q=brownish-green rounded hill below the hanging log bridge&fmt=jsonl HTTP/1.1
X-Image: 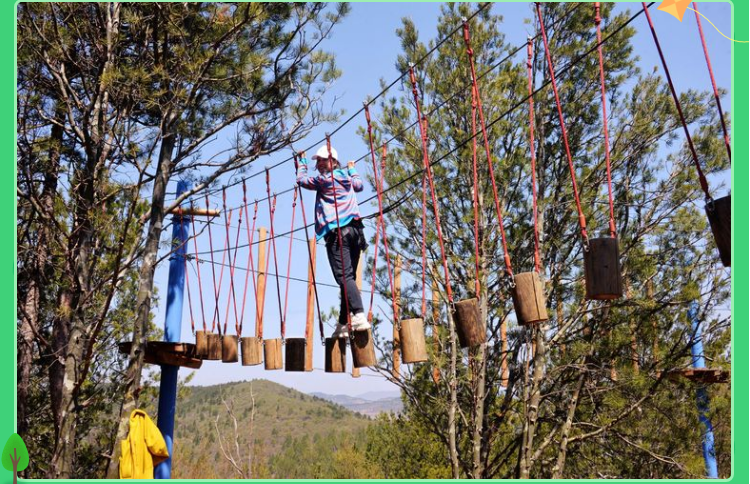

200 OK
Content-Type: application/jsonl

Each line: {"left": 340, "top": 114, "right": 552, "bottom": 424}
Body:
{"left": 172, "top": 380, "right": 370, "bottom": 479}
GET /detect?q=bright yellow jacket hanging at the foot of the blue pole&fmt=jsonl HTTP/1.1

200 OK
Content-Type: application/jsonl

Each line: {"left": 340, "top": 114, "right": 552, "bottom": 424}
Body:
{"left": 120, "top": 410, "right": 169, "bottom": 479}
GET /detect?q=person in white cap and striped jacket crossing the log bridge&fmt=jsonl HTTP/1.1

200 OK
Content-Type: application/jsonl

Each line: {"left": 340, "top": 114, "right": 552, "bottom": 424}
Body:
{"left": 297, "top": 145, "right": 370, "bottom": 338}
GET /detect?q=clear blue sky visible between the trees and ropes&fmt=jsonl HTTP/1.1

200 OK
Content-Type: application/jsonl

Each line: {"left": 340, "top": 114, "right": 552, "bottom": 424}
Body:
{"left": 155, "top": 2, "right": 732, "bottom": 395}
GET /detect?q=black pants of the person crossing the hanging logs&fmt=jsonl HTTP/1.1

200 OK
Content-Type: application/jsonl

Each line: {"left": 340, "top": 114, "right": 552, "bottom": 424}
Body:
{"left": 325, "top": 220, "right": 367, "bottom": 324}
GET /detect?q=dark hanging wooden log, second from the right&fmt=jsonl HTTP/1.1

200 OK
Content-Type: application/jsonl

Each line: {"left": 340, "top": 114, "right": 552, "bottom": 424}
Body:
{"left": 583, "top": 237, "right": 622, "bottom": 300}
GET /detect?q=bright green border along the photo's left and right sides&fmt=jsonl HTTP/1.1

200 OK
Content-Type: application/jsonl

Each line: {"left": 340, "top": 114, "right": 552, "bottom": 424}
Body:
{"left": 8, "top": 0, "right": 750, "bottom": 484}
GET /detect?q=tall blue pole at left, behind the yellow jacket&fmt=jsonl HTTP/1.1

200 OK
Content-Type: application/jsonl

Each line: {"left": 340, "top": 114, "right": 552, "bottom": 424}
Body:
{"left": 154, "top": 180, "right": 190, "bottom": 479}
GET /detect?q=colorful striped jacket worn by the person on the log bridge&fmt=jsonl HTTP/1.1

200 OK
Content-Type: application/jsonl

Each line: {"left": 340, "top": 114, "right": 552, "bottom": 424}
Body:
{"left": 297, "top": 158, "right": 364, "bottom": 240}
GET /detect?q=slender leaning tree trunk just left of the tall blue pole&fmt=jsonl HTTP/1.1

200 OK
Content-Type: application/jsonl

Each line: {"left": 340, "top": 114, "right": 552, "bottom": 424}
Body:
{"left": 107, "top": 134, "right": 175, "bottom": 479}
